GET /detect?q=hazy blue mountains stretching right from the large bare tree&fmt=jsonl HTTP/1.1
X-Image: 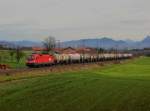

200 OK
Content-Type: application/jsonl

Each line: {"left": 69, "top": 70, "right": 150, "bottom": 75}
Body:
{"left": 62, "top": 36, "right": 150, "bottom": 49}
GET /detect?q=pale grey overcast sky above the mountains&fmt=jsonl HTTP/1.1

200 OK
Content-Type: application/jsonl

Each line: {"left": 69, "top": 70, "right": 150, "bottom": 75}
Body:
{"left": 0, "top": 0, "right": 150, "bottom": 41}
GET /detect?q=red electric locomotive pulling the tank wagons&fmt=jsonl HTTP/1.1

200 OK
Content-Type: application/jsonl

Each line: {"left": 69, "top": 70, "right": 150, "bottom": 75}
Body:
{"left": 26, "top": 53, "right": 56, "bottom": 67}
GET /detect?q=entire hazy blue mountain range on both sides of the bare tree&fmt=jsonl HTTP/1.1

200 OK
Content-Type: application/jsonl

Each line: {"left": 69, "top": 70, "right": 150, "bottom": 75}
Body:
{"left": 0, "top": 36, "right": 150, "bottom": 49}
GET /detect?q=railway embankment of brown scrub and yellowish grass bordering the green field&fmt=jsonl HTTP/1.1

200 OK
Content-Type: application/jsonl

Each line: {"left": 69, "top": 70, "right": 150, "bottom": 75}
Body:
{"left": 0, "top": 59, "right": 134, "bottom": 82}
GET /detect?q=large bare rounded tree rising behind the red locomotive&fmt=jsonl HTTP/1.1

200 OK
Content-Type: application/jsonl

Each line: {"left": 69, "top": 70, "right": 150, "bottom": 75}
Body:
{"left": 43, "top": 36, "right": 56, "bottom": 52}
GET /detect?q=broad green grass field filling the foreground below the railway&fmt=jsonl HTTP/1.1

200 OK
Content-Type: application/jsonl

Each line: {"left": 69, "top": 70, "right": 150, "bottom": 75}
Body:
{"left": 0, "top": 57, "right": 150, "bottom": 111}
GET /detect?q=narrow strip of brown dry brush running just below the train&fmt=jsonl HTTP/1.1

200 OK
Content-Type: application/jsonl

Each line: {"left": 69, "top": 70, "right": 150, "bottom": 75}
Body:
{"left": 0, "top": 59, "right": 131, "bottom": 76}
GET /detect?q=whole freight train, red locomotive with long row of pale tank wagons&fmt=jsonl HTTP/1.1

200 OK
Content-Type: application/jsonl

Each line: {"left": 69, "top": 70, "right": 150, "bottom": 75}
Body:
{"left": 26, "top": 53, "right": 133, "bottom": 67}
